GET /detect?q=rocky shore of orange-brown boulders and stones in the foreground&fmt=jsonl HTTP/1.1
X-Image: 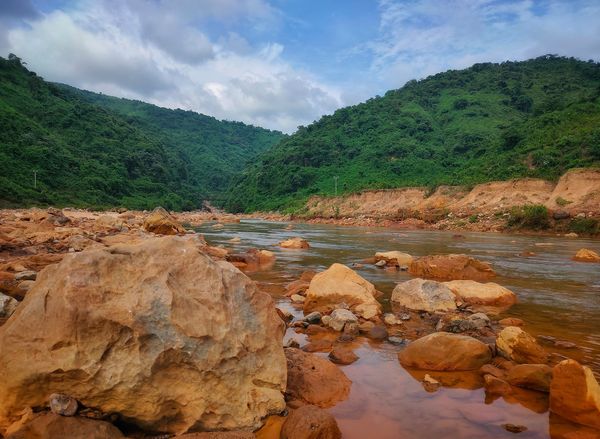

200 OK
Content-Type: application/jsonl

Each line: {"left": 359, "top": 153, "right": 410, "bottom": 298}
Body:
{"left": 0, "top": 209, "right": 600, "bottom": 439}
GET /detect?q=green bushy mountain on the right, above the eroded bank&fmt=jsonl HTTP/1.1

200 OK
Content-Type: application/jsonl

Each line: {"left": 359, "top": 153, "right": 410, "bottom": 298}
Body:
{"left": 225, "top": 55, "right": 600, "bottom": 211}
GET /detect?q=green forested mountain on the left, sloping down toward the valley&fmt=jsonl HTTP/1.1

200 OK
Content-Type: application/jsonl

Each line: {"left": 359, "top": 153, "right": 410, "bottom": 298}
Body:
{"left": 0, "top": 55, "right": 284, "bottom": 210}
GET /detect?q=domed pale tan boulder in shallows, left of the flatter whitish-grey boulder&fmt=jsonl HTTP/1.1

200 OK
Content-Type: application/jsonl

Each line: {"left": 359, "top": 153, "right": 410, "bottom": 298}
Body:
{"left": 304, "top": 264, "right": 381, "bottom": 319}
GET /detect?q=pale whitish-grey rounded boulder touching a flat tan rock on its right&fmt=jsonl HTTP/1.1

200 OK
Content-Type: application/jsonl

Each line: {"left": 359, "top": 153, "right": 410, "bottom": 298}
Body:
{"left": 392, "top": 278, "right": 456, "bottom": 312}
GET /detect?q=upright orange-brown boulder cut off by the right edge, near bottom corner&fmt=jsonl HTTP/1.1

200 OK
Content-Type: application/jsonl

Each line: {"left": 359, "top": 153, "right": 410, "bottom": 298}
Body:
{"left": 550, "top": 360, "right": 600, "bottom": 429}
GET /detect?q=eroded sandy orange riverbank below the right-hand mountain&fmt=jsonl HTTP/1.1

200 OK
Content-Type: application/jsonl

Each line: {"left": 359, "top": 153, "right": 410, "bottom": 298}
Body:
{"left": 293, "top": 169, "right": 600, "bottom": 235}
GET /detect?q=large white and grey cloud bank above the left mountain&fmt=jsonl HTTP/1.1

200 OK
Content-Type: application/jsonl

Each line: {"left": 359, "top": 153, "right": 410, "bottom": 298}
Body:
{"left": 4, "top": 0, "right": 341, "bottom": 132}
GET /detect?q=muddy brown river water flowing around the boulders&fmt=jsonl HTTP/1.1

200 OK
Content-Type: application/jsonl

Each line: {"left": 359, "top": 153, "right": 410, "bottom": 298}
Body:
{"left": 197, "top": 220, "right": 600, "bottom": 439}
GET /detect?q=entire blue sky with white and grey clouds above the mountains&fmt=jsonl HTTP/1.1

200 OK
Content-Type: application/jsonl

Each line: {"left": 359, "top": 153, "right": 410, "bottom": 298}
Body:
{"left": 0, "top": 0, "right": 600, "bottom": 133}
